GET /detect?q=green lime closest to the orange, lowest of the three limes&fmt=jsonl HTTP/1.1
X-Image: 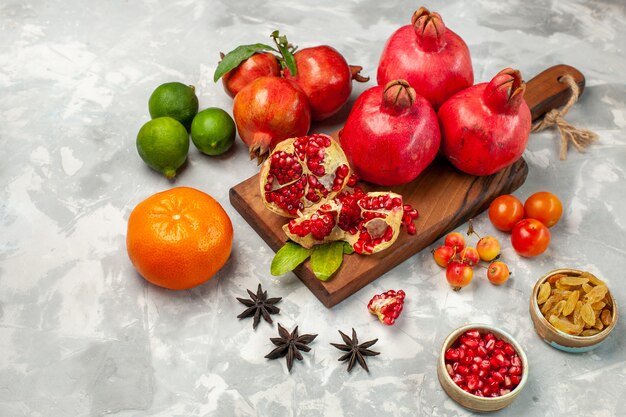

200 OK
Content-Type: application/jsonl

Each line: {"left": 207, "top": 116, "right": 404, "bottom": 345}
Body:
{"left": 137, "top": 117, "right": 189, "bottom": 178}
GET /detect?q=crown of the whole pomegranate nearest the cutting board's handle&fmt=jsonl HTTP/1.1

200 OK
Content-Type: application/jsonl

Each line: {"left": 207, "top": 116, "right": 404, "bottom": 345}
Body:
{"left": 483, "top": 68, "right": 526, "bottom": 113}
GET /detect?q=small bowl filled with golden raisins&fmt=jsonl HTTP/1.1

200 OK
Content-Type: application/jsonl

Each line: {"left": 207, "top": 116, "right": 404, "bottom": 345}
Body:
{"left": 530, "top": 269, "right": 617, "bottom": 353}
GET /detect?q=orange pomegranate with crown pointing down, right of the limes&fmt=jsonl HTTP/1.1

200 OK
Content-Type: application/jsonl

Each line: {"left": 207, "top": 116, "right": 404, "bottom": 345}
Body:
{"left": 233, "top": 77, "right": 311, "bottom": 160}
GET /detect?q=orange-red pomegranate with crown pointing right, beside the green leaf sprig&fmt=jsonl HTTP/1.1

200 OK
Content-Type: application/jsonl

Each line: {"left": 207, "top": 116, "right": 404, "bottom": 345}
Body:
{"left": 284, "top": 45, "right": 369, "bottom": 120}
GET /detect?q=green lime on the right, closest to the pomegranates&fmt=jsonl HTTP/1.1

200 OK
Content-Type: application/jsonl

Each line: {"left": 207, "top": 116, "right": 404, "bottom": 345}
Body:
{"left": 191, "top": 107, "right": 236, "bottom": 155}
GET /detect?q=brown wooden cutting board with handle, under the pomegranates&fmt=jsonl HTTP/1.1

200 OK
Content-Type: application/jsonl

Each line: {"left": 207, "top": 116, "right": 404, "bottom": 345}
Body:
{"left": 230, "top": 65, "right": 585, "bottom": 307}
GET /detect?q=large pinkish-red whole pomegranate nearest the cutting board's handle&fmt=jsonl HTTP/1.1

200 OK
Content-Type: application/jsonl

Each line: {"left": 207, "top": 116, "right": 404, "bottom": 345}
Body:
{"left": 438, "top": 68, "right": 531, "bottom": 175}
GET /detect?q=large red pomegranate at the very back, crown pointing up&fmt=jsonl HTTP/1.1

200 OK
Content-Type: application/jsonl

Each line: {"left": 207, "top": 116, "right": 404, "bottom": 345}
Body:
{"left": 377, "top": 7, "right": 474, "bottom": 109}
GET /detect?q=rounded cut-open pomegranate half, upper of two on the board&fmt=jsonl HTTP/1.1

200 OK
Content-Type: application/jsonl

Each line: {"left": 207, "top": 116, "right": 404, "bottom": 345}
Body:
{"left": 260, "top": 134, "right": 350, "bottom": 218}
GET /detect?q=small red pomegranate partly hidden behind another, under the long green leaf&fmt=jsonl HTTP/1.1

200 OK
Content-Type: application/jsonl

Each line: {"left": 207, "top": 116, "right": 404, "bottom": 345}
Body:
{"left": 222, "top": 53, "right": 280, "bottom": 97}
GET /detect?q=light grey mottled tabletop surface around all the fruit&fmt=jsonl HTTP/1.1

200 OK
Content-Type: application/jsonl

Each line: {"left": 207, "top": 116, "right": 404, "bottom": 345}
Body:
{"left": 0, "top": 0, "right": 626, "bottom": 417}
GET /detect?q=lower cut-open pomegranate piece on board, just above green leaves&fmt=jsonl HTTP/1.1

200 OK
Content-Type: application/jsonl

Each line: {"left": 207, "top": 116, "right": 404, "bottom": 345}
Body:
{"left": 283, "top": 187, "right": 417, "bottom": 255}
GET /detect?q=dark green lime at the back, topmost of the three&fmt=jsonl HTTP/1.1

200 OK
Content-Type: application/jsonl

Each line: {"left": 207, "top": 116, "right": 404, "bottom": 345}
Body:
{"left": 148, "top": 82, "right": 198, "bottom": 129}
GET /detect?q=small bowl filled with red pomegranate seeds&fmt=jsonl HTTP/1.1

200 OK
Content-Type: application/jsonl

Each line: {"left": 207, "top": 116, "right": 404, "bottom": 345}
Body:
{"left": 437, "top": 324, "right": 528, "bottom": 412}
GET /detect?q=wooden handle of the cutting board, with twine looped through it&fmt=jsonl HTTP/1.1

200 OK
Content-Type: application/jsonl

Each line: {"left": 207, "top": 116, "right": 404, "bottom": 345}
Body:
{"left": 524, "top": 65, "right": 585, "bottom": 120}
